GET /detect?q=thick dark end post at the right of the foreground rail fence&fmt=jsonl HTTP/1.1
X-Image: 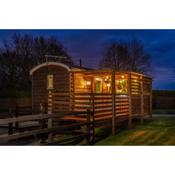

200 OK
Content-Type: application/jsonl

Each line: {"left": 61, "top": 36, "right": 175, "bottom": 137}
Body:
{"left": 87, "top": 109, "right": 95, "bottom": 145}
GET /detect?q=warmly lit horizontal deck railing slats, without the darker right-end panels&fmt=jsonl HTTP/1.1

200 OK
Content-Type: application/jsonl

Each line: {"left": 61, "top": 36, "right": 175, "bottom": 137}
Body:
{"left": 52, "top": 92, "right": 129, "bottom": 120}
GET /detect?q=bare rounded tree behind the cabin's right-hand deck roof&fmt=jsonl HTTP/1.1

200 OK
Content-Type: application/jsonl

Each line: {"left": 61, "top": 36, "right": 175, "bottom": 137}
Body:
{"left": 99, "top": 39, "right": 150, "bottom": 74}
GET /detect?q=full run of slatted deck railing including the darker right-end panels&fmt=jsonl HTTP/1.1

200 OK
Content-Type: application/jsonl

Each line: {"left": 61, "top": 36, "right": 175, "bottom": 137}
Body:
{"left": 52, "top": 91, "right": 151, "bottom": 120}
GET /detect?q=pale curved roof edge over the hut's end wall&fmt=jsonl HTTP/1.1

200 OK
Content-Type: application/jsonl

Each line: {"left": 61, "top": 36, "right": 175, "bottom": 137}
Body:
{"left": 30, "top": 62, "right": 71, "bottom": 75}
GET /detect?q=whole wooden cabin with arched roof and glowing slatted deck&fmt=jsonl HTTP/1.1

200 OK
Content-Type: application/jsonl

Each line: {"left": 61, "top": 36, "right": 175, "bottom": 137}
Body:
{"left": 30, "top": 62, "right": 152, "bottom": 123}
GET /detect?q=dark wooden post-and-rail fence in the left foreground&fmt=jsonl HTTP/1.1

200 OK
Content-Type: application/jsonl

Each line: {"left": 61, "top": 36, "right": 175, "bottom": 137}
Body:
{"left": 0, "top": 111, "right": 94, "bottom": 144}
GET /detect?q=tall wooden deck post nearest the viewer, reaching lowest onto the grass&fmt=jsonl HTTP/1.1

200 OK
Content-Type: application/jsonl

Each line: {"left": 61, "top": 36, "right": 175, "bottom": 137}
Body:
{"left": 112, "top": 70, "right": 116, "bottom": 135}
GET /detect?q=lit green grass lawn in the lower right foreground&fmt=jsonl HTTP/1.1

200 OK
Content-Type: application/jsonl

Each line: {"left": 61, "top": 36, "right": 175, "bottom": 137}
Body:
{"left": 96, "top": 117, "right": 175, "bottom": 145}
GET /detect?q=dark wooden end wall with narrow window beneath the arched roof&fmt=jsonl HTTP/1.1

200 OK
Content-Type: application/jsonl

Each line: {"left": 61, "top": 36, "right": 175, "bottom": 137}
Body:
{"left": 32, "top": 65, "right": 70, "bottom": 113}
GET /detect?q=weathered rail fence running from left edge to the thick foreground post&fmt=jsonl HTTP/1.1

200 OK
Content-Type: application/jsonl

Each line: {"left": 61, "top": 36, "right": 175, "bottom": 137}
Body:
{"left": 0, "top": 111, "right": 94, "bottom": 145}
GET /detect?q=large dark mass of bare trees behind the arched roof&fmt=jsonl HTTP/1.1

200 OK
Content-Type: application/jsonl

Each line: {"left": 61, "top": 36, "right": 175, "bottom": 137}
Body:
{"left": 0, "top": 33, "right": 73, "bottom": 94}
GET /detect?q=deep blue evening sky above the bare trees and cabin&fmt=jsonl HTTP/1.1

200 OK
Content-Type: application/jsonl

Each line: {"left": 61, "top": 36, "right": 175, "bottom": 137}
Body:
{"left": 0, "top": 30, "right": 175, "bottom": 89}
